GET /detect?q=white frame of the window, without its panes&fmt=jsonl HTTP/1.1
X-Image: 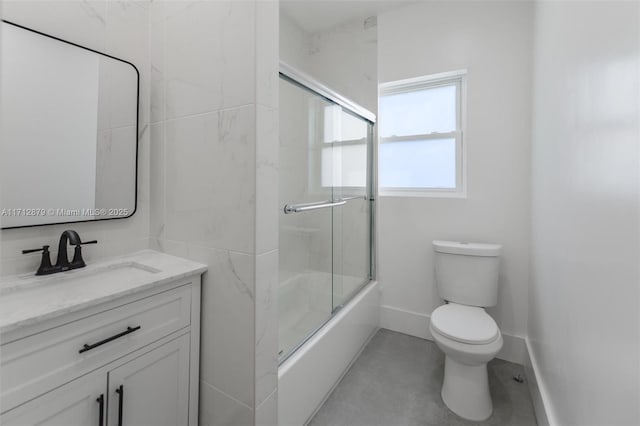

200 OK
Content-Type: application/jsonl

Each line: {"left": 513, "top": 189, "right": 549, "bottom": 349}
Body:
{"left": 378, "top": 69, "right": 467, "bottom": 198}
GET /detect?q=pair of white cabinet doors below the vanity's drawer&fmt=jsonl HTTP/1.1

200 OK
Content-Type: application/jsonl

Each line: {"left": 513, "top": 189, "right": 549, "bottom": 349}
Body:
{"left": 0, "top": 334, "right": 193, "bottom": 426}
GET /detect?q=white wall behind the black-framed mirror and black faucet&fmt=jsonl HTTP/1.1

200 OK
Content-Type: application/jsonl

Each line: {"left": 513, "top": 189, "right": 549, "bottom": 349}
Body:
{"left": 0, "top": 0, "right": 150, "bottom": 275}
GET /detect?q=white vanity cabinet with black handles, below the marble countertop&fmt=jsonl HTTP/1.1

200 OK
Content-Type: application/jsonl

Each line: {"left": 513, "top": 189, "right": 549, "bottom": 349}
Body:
{"left": 0, "top": 253, "right": 204, "bottom": 426}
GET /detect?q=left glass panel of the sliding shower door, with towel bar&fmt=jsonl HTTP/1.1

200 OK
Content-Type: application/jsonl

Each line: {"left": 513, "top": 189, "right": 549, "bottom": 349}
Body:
{"left": 278, "top": 79, "right": 333, "bottom": 357}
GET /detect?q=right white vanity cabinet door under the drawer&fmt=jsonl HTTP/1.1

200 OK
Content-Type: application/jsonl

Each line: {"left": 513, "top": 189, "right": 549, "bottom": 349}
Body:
{"left": 108, "top": 334, "right": 190, "bottom": 426}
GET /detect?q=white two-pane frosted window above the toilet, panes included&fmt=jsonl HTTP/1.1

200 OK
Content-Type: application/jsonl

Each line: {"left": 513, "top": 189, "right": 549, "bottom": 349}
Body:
{"left": 378, "top": 71, "right": 466, "bottom": 196}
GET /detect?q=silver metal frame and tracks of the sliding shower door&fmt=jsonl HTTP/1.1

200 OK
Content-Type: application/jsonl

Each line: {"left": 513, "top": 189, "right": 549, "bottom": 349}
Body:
{"left": 278, "top": 61, "right": 377, "bottom": 365}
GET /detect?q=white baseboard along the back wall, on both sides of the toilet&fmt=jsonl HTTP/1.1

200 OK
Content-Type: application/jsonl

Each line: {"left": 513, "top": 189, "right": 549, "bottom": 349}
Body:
{"left": 380, "top": 305, "right": 527, "bottom": 365}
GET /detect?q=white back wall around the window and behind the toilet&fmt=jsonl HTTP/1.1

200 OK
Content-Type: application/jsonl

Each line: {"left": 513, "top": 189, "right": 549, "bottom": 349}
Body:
{"left": 378, "top": 2, "right": 532, "bottom": 361}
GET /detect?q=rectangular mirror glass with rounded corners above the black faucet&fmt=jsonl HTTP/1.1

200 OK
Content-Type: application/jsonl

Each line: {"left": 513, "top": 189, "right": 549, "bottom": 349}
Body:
{"left": 0, "top": 21, "right": 139, "bottom": 229}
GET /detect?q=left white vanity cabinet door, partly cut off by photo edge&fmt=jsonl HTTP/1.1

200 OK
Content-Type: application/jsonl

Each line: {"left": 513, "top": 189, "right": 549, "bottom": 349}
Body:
{"left": 0, "top": 372, "right": 107, "bottom": 426}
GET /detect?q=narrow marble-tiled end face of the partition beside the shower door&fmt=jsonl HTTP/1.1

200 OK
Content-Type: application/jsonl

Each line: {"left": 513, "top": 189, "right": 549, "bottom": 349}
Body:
{"left": 254, "top": 0, "right": 280, "bottom": 420}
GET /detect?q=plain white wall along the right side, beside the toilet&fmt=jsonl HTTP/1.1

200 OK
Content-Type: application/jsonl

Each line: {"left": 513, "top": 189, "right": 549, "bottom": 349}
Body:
{"left": 529, "top": 2, "right": 640, "bottom": 425}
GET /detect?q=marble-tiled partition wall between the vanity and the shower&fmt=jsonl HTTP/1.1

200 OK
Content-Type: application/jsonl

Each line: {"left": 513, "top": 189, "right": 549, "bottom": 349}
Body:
{"left": 149, "top": 0, "right": 278, "bottom": 425}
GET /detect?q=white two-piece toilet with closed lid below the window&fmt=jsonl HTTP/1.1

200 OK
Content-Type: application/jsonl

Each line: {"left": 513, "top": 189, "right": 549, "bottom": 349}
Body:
{"left": 429, "top": 241, "right": 503, "bottom": 421}
